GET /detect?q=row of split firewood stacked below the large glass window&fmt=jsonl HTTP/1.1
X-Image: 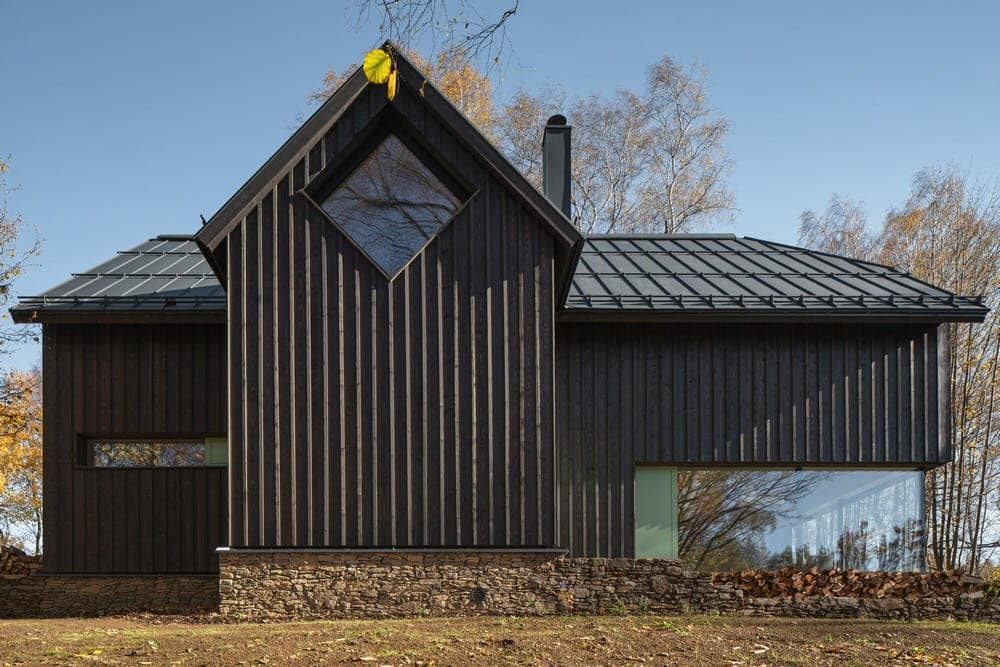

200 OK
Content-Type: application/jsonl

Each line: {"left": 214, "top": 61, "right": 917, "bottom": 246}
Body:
{"left": 713, "top": 568, "right": 982, "bottom": 600}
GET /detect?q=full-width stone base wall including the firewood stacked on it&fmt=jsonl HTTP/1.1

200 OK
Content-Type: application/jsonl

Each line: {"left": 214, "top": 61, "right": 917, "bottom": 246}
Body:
{"left": 0, "top": 551, "right": 1000, "bottom": 623}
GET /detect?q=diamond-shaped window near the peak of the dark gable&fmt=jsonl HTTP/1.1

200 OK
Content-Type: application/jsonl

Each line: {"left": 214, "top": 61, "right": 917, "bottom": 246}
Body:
{"left": 322, "top": 134, "right": 460, "bottom": 277}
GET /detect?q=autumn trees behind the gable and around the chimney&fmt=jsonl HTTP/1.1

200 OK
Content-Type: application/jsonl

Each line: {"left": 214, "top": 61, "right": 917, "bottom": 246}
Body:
{"left": 312, "top": 53, "right": 733, "bottom": 233}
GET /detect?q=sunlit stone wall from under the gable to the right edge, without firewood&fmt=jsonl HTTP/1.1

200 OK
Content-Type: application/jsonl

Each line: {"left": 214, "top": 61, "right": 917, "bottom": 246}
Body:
{"left": 219, "top": 551, "right": 1000, "bottom": 622}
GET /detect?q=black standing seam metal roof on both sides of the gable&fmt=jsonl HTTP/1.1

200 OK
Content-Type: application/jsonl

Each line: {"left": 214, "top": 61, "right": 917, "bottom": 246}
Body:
{"left": 12, "top": 234, "right": 987, "bottom": 319}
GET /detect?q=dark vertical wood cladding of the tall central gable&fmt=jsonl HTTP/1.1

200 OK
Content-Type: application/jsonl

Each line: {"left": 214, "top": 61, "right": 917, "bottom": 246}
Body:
{"left": 224, "top": 82, "right": 555, "bottom": 547}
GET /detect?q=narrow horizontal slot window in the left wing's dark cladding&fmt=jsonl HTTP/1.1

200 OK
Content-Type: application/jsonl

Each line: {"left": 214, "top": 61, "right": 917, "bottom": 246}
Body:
{"left": 86, "top": 438, "right": 228, "bottom": 468}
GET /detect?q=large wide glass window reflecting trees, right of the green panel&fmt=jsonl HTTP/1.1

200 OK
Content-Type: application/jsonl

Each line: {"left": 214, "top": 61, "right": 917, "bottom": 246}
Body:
{"left": 677, "top": 470, "right": 925, "bottom": 571}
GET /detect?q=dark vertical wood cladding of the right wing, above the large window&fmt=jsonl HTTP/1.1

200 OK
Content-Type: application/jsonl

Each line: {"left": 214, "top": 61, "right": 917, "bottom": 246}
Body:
{"left": 556, "top": 323, "right": 951, "bottom": 557}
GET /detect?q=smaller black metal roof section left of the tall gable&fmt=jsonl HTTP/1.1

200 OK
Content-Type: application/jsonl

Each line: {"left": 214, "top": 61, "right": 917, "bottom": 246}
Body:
{"left": 11, "top": 235, "right": 226, "bottom": 321}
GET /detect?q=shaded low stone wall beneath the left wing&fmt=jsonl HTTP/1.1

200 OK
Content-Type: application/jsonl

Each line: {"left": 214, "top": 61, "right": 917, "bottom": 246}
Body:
{"left": 0, "top": 574, "right": 219, "bottom": 618}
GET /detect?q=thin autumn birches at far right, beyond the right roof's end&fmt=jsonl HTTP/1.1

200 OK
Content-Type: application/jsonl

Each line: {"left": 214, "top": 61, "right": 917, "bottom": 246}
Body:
{"left": 799, "top": 169, "right": 1000, "bottom": 570}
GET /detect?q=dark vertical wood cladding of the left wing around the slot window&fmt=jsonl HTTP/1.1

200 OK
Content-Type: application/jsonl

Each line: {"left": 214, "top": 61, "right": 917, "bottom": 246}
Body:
{"left": 43, "top": 323, "right": 226, "bottom": 573}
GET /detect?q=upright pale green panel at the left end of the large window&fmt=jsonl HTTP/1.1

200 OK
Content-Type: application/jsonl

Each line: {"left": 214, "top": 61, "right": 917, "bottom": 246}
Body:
{"left": 635, "top": 466, "right": 677, "bottom": 558}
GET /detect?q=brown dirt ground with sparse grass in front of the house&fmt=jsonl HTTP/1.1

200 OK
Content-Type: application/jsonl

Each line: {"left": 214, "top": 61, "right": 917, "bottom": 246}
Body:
{"left": 0, "top": 616, "right": 1000, "bottom": 666}
